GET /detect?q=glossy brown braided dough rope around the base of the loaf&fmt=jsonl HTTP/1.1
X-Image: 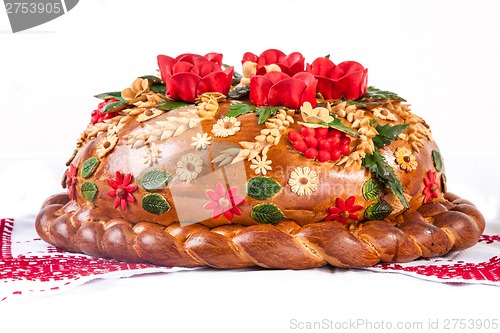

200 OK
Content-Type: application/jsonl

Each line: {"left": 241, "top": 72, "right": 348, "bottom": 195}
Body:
{"left": 35, "top": 193, "right": 485, "bottom": 269}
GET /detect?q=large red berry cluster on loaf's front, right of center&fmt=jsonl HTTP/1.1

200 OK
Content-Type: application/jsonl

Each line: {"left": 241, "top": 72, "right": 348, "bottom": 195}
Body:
{"left": 288, "top": 126, "right": 351, "bottom": 162}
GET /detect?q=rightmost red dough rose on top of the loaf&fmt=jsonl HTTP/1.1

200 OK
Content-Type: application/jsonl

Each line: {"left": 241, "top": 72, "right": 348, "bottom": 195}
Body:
{"left": 306, "top": 58, "right": 368, "bottom": 100}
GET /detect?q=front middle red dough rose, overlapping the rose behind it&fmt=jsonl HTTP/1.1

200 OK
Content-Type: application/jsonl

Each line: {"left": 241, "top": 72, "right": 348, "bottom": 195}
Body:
{"left": 250, "top": 72, "right": 318, "bottom": 109}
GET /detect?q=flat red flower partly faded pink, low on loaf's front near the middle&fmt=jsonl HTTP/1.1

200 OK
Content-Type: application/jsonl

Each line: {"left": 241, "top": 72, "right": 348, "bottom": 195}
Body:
{"left": 203, "top": 183, "right": 245, "bottom": 221}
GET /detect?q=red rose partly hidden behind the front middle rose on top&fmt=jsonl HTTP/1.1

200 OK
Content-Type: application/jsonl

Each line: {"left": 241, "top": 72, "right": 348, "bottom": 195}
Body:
{"left": 241, "top": 49, "right": 304, "bottom": 76}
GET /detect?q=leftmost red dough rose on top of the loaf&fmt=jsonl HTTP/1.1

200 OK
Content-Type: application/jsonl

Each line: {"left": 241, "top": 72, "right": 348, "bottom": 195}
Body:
{"left": 158, "top": 53, "right": 234, "bottom": 102}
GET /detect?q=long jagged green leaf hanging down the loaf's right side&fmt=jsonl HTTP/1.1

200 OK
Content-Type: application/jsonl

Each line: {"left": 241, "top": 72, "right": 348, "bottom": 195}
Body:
{"left": 362, "top": 150, "right": 410, "bottom": 209}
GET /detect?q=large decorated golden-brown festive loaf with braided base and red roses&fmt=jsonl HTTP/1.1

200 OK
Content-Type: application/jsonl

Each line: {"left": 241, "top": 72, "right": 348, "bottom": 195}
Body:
{"left": 36, "top": 50, "right": 484, "bottom": 269}
